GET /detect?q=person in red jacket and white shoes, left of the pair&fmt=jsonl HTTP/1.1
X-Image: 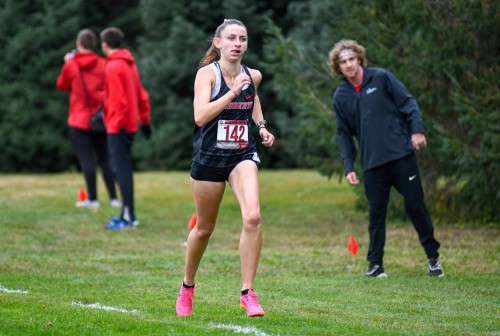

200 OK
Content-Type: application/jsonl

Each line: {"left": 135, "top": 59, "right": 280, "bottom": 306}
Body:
{"left": 56, "top": 29, "right": 121, "bottom": 208}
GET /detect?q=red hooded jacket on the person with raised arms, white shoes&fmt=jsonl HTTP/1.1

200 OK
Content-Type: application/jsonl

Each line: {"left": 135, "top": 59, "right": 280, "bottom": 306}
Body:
{"left": 56, "top": 52, "right": 106, "bottom": 130}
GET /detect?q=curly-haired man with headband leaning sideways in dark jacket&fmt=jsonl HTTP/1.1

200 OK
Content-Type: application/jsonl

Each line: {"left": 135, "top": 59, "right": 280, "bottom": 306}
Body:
{"left": 328, "top": 40, "right": 444, "bottom": 277}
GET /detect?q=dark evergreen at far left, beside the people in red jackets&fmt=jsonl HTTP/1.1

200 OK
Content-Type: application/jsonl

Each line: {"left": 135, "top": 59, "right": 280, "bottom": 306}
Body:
{"left": 0, "top": 0, "right": 141, "bottom": 172}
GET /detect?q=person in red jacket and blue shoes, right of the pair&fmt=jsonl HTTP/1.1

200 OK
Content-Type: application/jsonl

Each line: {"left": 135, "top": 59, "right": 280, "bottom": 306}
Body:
{"left": 100, "top": 27, "right": 151, "bottom": 230}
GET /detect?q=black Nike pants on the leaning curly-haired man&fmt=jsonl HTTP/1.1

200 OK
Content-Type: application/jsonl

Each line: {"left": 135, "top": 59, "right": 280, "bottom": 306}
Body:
{"left": 364, "top": 154, "right": 440, "bottom": 265}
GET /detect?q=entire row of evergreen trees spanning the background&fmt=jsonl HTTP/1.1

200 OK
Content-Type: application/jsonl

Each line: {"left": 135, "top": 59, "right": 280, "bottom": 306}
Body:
{"left": 0, "top": 0, "right": 500, "bottom": 221}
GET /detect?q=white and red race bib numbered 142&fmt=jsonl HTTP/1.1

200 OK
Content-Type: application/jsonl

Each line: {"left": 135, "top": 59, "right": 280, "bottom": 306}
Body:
{"left": 215, "top": 120, "right": 248, "bottom": 149}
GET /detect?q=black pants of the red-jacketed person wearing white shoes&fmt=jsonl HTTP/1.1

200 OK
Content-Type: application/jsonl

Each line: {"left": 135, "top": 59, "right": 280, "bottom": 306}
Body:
{"left": 68, "top": 127, "right": 116, "bottom": 201}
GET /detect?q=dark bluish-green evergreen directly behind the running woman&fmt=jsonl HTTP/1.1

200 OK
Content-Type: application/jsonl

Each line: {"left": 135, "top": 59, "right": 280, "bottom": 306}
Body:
{"left": 135, "top": 0, "right": 292, "bottom": 169}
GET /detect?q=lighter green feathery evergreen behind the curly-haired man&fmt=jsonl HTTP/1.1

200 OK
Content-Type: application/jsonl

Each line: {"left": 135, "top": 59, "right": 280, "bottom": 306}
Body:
{"left": 266, "top": 0, "right": 500, "bottom": 221}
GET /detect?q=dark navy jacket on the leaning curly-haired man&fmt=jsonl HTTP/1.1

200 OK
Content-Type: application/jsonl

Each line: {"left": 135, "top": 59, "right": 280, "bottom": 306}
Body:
{"left": 333, "top": 68, "right": 424, "bottom": 174}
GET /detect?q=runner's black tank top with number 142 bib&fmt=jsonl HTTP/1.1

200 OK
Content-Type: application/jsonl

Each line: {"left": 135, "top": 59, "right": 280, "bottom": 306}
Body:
{"left": 193, "top": 62, "right": 256, "bottom": 167}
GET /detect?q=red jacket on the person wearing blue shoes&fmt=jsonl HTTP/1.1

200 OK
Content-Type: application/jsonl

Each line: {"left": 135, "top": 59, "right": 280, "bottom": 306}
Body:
{"left": 104, "top": 49, "right": 151, "bottom": 133}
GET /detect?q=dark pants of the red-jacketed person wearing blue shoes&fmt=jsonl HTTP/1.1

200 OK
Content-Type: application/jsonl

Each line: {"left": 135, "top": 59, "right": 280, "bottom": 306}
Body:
{"left": 108, "top": 130, "right": 135, "bottom": 220}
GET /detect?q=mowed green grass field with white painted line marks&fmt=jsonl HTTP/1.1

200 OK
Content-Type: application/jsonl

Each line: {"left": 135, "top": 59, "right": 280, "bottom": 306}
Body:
{"left": 0, "top": 170, "right": 500, "bottom": 336}
